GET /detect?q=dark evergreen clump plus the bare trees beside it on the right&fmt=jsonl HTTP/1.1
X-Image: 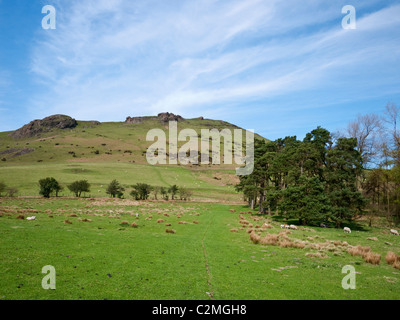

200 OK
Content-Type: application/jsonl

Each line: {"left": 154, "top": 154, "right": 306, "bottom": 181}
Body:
{"left": 236, "top": 104, "right": 400, "bottom": 227}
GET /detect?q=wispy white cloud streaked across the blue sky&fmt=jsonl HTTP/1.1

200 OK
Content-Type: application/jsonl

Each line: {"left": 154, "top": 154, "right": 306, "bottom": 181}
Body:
{"left": 31, "top": 0, "right": 400, "bottom": 130}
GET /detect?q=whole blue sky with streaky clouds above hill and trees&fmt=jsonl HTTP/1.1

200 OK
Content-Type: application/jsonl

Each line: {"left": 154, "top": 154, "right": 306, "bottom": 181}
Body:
{"left": 0, "top": 0, "right": 400, "bottom": 140}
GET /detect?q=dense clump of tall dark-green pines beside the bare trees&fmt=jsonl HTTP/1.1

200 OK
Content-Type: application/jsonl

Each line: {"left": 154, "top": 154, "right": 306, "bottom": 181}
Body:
{"left": 236, "top": 127, "right": 366, "bottom": 227}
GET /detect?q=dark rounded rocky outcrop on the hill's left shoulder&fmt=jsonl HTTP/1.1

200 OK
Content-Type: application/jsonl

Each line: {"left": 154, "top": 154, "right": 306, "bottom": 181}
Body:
{"left": 11, "top": 114, "right": 78, "bottom": 139}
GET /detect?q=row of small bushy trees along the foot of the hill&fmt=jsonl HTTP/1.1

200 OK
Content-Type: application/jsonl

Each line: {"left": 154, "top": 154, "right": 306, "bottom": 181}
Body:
{"left": 39, "top": 178, "right": 192, "bottom": 200}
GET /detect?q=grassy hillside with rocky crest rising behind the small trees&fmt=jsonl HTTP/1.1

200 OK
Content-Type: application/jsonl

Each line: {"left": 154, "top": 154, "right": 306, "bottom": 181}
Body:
{"left": 0, "top": 113, "right": 264, "bottom": 201}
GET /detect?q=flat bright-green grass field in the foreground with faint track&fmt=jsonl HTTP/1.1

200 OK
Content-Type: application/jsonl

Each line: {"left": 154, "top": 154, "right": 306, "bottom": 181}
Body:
{"left": 0, "top": 198, "right": 400, "bottom": 300}
